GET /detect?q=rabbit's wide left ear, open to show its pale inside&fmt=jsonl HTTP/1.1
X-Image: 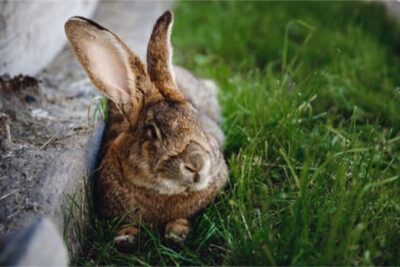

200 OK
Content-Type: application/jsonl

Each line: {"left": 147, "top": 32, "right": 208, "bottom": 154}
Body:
{"left": 65, "top": 17, "right": 153, "bottom": 121}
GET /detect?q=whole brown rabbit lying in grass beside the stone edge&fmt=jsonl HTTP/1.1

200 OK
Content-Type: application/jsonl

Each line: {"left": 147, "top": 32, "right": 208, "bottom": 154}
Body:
{"left": 65, "top": 11, "right": 228, "bottom": 247}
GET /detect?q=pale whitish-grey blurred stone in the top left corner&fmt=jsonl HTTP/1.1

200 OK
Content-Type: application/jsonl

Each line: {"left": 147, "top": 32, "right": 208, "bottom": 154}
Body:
{"left": 0, "top": 0, "right": 97, "bottom": 76}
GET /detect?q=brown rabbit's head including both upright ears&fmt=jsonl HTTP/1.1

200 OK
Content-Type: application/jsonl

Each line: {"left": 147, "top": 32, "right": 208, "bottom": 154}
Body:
{"left": 65, "top": 11, "right": 227, "bottom": 195}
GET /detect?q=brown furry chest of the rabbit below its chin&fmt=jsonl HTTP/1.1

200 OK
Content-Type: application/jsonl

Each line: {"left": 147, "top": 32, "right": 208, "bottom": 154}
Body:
{"left": 97, "top": 144, "right": 222, "bottom": 226}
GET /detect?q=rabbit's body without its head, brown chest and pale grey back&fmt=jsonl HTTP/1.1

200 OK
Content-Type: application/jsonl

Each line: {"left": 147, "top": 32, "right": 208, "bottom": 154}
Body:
{"left": 96, "top": 66, "right": 227, "bottom": 226}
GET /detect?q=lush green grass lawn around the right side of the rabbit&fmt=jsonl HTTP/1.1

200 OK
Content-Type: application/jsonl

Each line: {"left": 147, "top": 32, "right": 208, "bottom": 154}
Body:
{"left": 73, "top": 2, "right": 400, "bottom": 265}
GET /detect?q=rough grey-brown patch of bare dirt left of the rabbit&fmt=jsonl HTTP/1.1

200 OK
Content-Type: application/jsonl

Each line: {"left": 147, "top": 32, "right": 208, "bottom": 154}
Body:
{"left": 0, "top": 50, "right": 94, "bottom": 234}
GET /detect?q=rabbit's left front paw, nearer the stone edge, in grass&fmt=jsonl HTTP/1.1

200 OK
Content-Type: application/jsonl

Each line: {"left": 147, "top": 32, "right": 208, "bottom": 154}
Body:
{"left": 114, "top": 226, "right": 139, "bottom": 253}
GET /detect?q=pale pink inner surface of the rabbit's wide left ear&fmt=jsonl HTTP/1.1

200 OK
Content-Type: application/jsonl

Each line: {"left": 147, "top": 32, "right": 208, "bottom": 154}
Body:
{"left": 80, "top": 31, "right": 134, "bottom": 104}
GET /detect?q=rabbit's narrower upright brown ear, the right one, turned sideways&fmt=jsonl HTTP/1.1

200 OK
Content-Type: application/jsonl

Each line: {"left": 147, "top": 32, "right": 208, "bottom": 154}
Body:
{"left": 147, "top": 10, "right": 184, "bottom": 101}
